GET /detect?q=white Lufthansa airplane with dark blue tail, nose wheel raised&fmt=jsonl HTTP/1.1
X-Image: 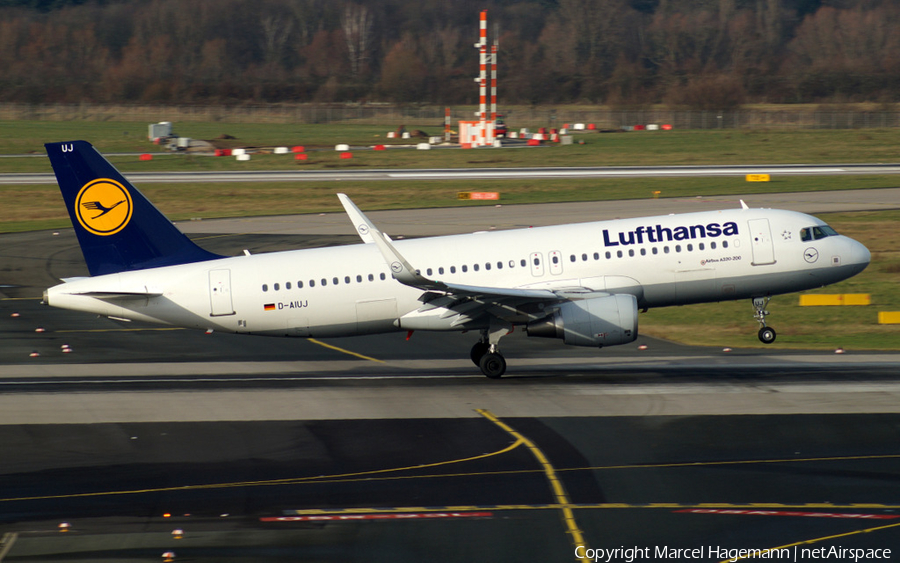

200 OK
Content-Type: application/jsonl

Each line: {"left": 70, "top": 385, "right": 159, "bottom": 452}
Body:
{"left": 44, "top": 141, "right": 871, "bottom": 378}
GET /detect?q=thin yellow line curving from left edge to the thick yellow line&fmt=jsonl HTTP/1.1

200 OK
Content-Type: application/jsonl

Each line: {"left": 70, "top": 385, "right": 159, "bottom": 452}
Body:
{"left": 0, "top": 440, "right": 525, "bottom": 502}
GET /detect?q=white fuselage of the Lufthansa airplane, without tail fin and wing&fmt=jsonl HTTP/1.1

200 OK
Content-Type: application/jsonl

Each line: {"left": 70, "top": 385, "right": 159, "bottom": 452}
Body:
{"left": 46, "top": 209, "right": 870, "bottom": 337}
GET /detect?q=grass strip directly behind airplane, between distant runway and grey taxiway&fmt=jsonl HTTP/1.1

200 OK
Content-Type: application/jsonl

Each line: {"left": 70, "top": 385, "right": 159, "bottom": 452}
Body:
{"left": 7, "top": 176, "right": 900, "bottom": 233}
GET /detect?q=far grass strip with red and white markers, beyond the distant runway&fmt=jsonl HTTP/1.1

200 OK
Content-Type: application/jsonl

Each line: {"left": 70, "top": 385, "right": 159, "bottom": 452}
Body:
{"left": 0, "top": 122, "right": 900, "bottom": 173}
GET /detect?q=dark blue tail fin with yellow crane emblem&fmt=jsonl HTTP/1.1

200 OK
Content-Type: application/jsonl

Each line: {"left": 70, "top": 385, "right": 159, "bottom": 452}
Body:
{"left": 44, "top": 141, "right": 221, "bottom": 276}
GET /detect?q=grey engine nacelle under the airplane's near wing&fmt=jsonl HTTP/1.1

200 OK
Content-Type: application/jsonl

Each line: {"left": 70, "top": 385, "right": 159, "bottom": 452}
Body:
{"left": 526, "top": 294, "right": 638, "bottom": 347}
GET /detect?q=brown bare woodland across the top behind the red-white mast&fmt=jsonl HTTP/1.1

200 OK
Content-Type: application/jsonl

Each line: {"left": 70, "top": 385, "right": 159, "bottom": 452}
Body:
{"left": 0, "top": 0, "right": 900, "bottom": 109}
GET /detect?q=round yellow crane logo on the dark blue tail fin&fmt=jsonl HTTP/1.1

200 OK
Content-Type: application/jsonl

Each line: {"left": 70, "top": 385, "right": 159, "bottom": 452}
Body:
{"left": 75, "top": 178, "right": 134, "bottom": 237}
